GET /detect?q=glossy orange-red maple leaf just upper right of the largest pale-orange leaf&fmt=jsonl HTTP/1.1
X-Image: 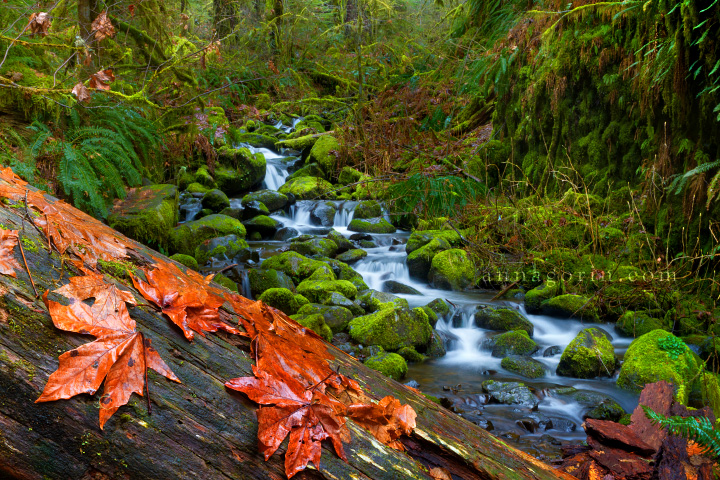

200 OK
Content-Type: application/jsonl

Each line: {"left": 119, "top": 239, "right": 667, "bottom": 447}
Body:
{"left": 132, "top": 261, "right": 241, "bottom": 340}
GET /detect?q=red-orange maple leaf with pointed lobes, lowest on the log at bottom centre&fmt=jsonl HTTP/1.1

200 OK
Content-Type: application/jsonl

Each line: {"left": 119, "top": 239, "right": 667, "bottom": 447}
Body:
{"left": 225, "top": 365, "right": 347, "bottom": 478}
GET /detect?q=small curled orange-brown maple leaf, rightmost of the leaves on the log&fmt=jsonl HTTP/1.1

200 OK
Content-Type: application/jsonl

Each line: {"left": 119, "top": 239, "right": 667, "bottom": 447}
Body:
{"left": 348, "top": 396, "right": 417, "bottom": 450}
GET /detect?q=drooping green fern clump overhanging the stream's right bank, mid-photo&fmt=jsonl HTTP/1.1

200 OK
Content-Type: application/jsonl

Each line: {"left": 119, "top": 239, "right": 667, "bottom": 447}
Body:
{"left": 388, "top": 173, "right": 485, "bottom": 218}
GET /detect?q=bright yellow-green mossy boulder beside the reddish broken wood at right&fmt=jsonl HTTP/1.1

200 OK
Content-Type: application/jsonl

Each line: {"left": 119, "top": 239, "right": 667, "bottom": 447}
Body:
{"left": 617, "top": 330, "right": 702, "bottom": 404}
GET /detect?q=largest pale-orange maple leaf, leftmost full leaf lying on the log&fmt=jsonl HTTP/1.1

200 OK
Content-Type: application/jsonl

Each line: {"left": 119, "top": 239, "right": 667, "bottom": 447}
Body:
{"left": 35, "top": 274, "right": 180, "bottom": 428}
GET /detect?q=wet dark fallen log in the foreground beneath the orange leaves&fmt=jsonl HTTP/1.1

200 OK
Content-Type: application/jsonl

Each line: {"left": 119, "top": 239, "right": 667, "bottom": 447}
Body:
{"left": 0, "top": 188, "right": 572, "bottom": 480}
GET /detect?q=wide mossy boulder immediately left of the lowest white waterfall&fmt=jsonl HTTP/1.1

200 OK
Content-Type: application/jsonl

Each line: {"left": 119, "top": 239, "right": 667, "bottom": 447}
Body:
{"left": 349, "top": 304, "right": 432, "bottom": 351}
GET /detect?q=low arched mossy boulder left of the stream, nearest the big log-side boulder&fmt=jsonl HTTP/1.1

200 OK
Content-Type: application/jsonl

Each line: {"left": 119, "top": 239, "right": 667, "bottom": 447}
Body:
{"left": 170, "top": 214, "right": 246, "bottom": 255}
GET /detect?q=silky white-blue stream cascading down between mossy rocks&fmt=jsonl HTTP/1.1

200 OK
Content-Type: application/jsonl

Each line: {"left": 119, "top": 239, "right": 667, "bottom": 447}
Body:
{"left": 180, "top": 122, "right": 638, "bottom": 459}
